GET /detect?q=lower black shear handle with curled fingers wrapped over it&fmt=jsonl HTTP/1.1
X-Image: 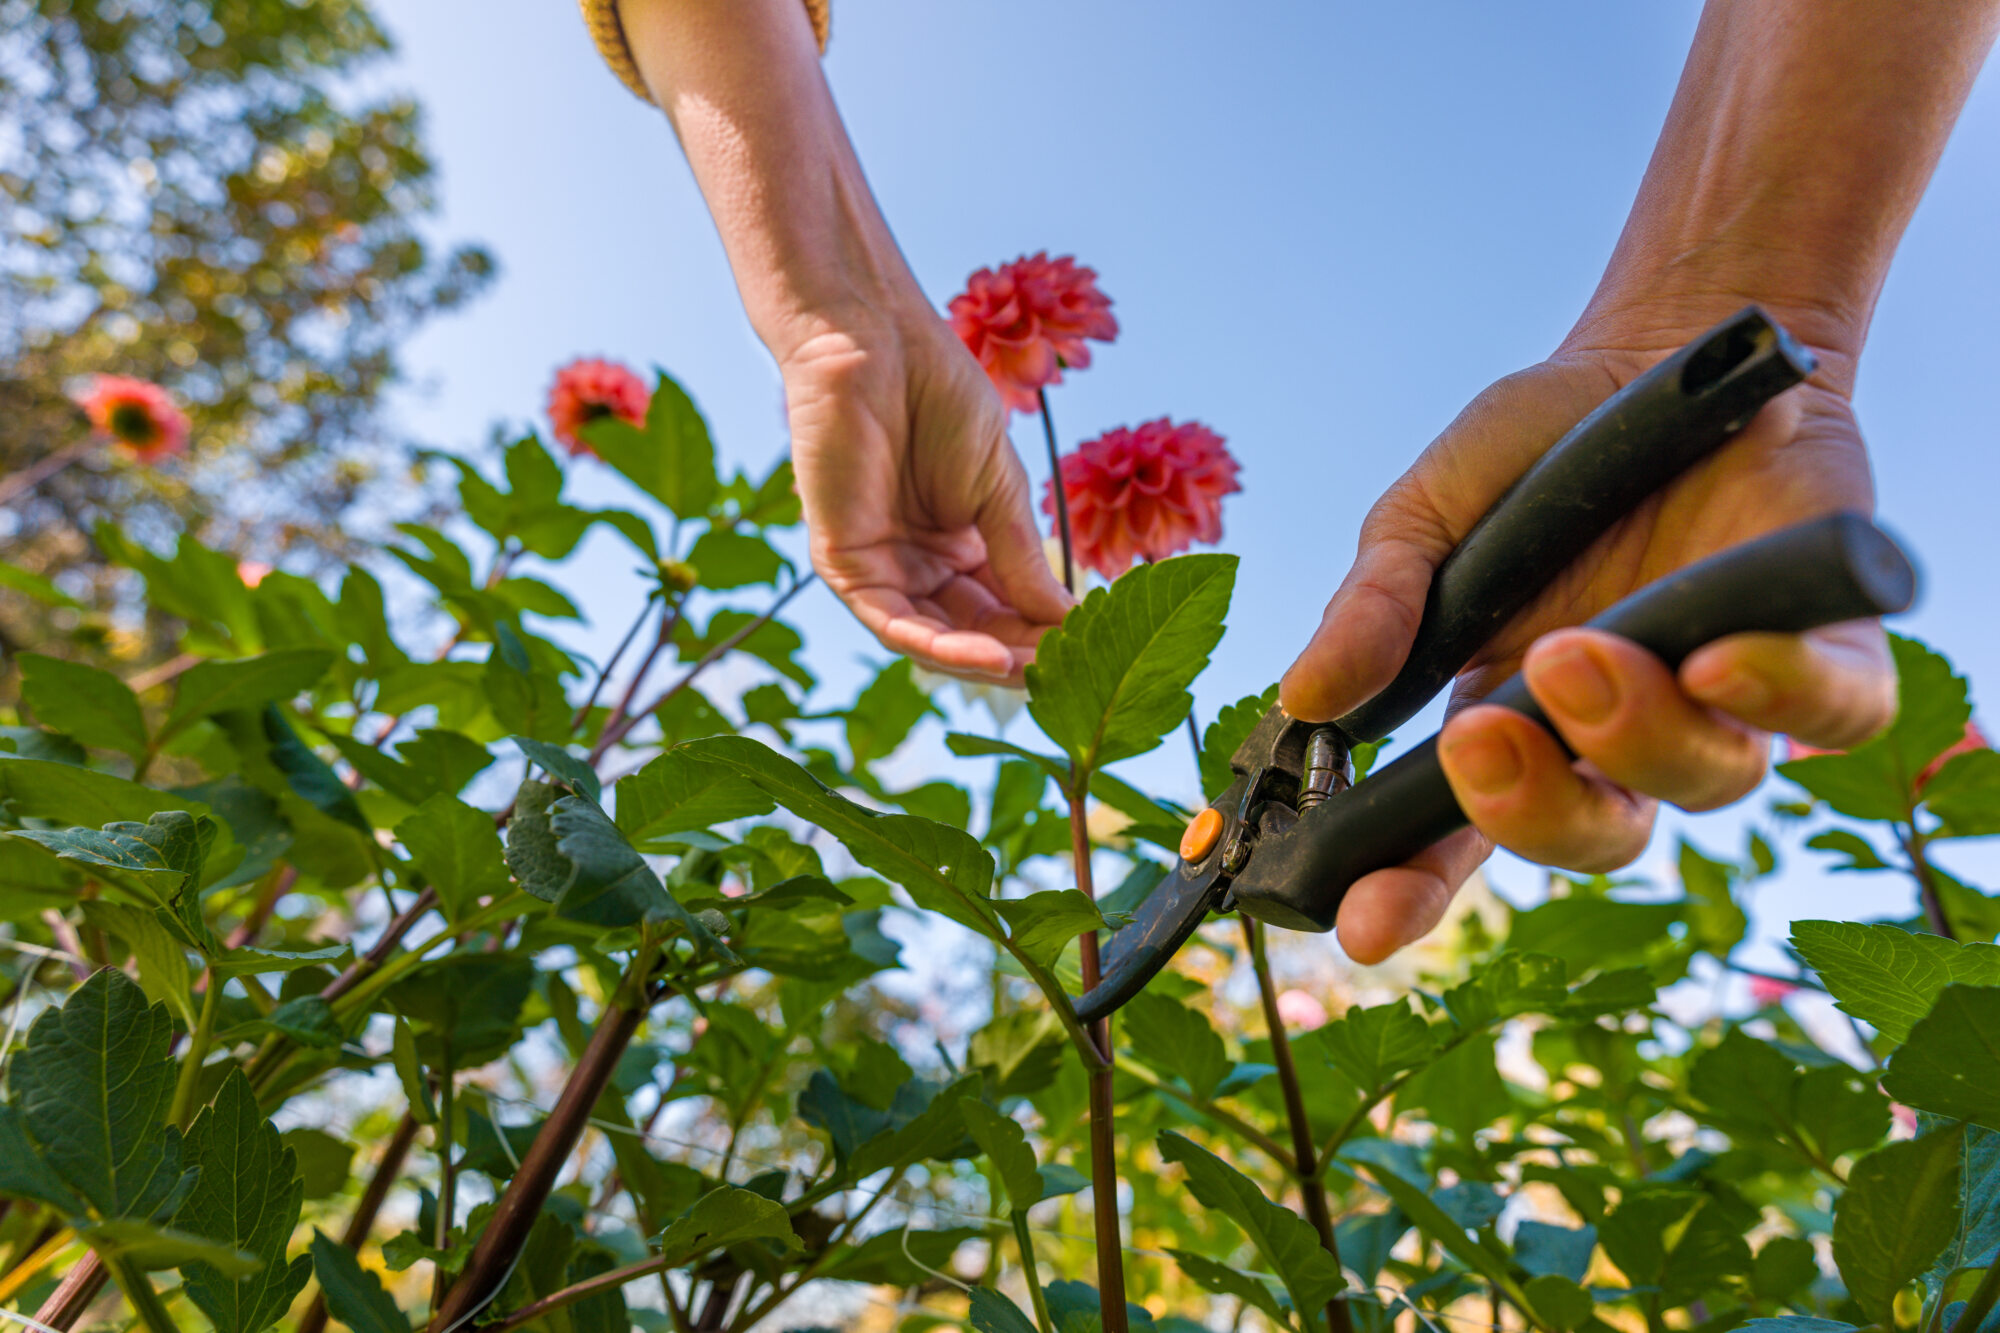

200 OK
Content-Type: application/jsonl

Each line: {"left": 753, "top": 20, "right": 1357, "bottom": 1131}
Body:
{"left": 1232, "top": 514, "right": 1916, "bottom": 931}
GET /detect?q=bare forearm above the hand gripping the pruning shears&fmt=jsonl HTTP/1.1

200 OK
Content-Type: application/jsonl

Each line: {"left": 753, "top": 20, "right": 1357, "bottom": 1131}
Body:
{"left": 1572, "top": 0, "right": 2000, "bottom": 390}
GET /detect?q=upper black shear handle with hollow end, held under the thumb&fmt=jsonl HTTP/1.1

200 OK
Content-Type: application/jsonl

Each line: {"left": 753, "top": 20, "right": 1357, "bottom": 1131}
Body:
{"left": 1338, "top": 306, "right": 1814, "bottom": 741}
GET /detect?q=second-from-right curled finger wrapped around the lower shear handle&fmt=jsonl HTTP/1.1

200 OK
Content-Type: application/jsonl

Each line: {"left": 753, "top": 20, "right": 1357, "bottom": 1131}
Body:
{"left": 1522, "top": 628, "right": 1770, "bottom": 811}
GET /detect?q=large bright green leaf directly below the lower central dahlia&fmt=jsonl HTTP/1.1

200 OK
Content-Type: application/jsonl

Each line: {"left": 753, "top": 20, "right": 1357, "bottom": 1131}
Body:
{"left": 1028, "top": 554, "right": 1236, "bottom": 773}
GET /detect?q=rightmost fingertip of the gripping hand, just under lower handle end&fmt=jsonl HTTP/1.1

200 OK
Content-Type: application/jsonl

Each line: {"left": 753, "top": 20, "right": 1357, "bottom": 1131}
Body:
{"left": 1680, "top": 620, "right": 1896, "bottom": 751}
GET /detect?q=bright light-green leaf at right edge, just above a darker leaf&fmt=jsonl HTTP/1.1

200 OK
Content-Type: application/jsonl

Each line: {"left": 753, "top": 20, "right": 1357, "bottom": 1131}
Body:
{"left": 1792, "top": 921, "right": 2000, "bottom": 1043}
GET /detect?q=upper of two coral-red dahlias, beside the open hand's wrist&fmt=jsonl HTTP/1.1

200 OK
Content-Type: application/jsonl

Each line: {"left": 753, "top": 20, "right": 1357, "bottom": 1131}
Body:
{"left": 952, "top": 250, "right": 1118, "bottom": 412}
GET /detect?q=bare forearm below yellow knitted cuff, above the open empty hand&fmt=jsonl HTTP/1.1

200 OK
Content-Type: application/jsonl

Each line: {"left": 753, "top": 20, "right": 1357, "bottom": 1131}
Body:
{"left": 620, "top": 0, "right": 922, "bottom": 360}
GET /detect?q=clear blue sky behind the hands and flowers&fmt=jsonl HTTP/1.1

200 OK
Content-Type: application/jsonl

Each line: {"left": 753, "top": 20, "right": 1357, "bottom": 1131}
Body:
{"left": 376, "top": 0, "right": 2000, "bottom": 959}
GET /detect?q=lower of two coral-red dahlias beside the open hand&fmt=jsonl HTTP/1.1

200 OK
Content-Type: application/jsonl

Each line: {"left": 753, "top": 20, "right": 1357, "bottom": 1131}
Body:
{"left": 1042, "top": 416, "right": 1242, "bottom": 578}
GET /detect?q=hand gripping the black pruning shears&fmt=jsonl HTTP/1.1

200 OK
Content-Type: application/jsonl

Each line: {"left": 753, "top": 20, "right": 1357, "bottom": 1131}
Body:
{"left": 1282, "top": 328, "right": 1896, "bottom": 963}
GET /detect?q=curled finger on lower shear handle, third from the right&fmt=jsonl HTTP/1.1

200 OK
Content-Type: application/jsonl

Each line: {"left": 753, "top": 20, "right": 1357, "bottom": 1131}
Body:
{"left": 1438, "top": 705, "right": 1656, "bottom": 875}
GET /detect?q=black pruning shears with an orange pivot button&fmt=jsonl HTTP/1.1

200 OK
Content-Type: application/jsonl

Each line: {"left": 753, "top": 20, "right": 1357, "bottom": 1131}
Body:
{"left": 1076, "top": 306, "right": 1916, "bottom": 1023}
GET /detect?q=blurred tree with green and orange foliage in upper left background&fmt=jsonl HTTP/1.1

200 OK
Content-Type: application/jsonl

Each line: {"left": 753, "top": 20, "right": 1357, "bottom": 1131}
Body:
{"left": 0, "top": 0, "right": 492, "bottom": 658}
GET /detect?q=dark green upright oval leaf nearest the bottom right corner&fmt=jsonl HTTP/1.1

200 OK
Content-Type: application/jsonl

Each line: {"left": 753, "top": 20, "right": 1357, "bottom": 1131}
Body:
{"left": 1834, "top": 1125, "right": 1966, "bottom": 1329}
